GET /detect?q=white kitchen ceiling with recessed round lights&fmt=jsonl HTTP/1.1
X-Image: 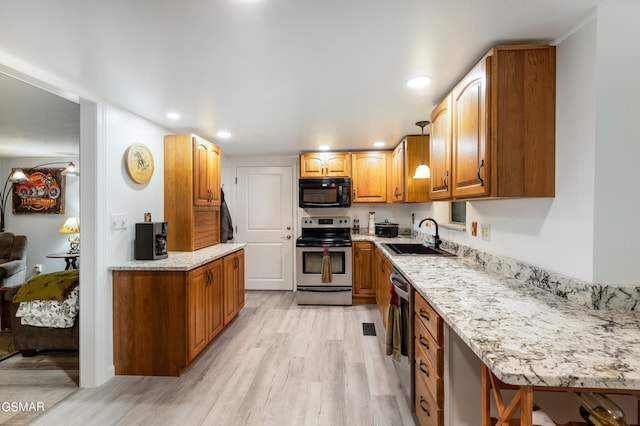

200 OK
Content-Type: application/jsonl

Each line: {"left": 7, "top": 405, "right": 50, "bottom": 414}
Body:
{"left": 0, "top": 0, "right": 600, "bottom": 155}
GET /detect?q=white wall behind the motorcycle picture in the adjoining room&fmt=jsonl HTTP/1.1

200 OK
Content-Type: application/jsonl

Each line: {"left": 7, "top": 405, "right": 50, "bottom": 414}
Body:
{"left": 0, "top": 157, "right": 81, "bottom": 278}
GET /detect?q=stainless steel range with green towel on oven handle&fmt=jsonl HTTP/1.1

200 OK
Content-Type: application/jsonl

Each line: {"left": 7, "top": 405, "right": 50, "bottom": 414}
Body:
{"left": 296, "top": 216, "right": 352, "bottom": 305}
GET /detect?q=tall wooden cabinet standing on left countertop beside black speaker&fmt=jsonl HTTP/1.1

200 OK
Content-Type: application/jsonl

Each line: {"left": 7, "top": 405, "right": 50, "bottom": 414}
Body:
{"left": 164, "top": 135, "right": 220, "bottom": 251}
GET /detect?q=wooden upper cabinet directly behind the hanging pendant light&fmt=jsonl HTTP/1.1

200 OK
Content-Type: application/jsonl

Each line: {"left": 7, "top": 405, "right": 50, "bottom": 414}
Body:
{"left": 387, "top": 135, "right": 429, "bottom": 203}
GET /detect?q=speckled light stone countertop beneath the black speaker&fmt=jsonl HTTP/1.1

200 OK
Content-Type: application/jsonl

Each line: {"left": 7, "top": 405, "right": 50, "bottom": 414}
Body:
{"left": 109, "top": 244, "right": 246, "bottom": 271}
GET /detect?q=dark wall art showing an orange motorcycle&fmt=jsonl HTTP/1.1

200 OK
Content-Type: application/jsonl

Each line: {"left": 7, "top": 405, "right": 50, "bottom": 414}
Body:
{"left": 12, "top": 168, "right": 66, "bottom": 214}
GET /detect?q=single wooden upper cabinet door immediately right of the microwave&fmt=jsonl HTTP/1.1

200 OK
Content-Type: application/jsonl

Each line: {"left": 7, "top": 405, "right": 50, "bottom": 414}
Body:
{"left": 351, "top": 151, "right": 387, "bottom": 203}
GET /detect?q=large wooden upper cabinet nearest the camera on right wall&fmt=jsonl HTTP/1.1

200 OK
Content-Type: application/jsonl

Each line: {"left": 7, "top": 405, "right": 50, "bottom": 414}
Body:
{"left": 430, "top": 45, "right": 556, "bottom": 199}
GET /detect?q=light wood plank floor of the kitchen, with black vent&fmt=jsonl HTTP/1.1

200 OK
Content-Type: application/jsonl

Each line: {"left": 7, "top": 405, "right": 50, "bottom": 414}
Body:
{"left": 32, "top": 291, "right": 414, "bottom": 426}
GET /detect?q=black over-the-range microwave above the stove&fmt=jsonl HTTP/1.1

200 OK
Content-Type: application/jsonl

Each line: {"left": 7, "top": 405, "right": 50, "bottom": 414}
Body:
{"left": 298, "top": 178, "right": 351, "bottom": 208}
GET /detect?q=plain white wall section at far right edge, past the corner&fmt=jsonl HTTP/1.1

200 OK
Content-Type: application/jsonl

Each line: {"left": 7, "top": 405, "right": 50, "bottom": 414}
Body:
{"left": 593, "top": 0, "right": 640, "bottom": 284}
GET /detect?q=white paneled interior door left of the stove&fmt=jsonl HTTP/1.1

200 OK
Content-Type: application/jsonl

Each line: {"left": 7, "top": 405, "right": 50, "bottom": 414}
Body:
{"left": 236, "top": 166, "right": 295, "bottom": 290}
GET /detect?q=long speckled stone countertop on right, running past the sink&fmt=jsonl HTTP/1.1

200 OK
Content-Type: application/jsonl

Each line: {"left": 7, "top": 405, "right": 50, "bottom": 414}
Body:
{"left": 352, "top": 235, "right": 640, "bottom": 390}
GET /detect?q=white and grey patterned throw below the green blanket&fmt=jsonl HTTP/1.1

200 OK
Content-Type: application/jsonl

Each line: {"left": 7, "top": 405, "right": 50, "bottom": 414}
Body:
{"left": 16, "top": 285, "right": 80, "bottom": 328}
